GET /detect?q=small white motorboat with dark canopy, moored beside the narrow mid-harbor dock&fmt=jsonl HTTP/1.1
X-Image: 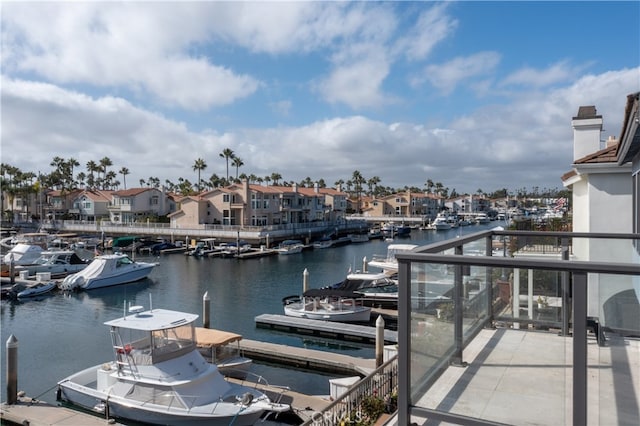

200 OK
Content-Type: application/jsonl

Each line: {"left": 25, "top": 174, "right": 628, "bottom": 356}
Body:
{"left": 282, "top": 288, "right": 371, "bottom": 322}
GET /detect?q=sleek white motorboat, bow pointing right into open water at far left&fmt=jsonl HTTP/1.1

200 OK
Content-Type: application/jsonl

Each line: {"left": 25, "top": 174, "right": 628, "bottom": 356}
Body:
{"left": 59, "top": 254, "right": 156, "bottom": 290}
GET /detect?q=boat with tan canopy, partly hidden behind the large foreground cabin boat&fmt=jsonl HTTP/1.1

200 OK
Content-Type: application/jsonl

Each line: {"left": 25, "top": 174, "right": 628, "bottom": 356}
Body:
{"left": 195, "top": 327, "right": 253, "bottom": 380}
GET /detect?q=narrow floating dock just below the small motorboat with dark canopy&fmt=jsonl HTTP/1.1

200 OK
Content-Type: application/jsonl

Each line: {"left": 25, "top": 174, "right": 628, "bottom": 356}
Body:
{"left": 255, "top": 314, "right": 398, "bottom": 344}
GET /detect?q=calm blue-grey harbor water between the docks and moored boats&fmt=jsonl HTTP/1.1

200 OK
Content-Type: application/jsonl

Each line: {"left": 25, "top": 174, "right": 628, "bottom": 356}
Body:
{"left": 0, "top": 222, "right": 500, "bottom": 403}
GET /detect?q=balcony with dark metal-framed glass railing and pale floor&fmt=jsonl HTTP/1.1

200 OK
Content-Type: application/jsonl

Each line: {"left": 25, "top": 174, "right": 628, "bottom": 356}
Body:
{"left": 396, "top": 231, "right": 640, "bottom": 425}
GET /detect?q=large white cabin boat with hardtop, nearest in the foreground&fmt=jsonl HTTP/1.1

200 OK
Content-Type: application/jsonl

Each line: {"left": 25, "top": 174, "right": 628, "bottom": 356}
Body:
{"left": 58, "top": 306, "right": 290, "bottom": 426}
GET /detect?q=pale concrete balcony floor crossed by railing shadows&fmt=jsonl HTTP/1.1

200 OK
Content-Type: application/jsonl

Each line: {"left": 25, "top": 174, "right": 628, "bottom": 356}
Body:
{"left": 411, "top": 328, "right": 640, "bottom": 425}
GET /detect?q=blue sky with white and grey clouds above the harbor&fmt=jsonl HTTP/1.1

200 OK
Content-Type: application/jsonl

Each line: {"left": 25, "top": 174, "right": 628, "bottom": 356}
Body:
{"left": 0, "top": 1, "right": 640, "bottom": 193}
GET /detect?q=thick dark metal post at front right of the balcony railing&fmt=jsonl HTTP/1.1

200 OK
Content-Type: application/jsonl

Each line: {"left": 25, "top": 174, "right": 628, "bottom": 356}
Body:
{"left": 573, "top": 272, "right": 587, "bottom": 425}
